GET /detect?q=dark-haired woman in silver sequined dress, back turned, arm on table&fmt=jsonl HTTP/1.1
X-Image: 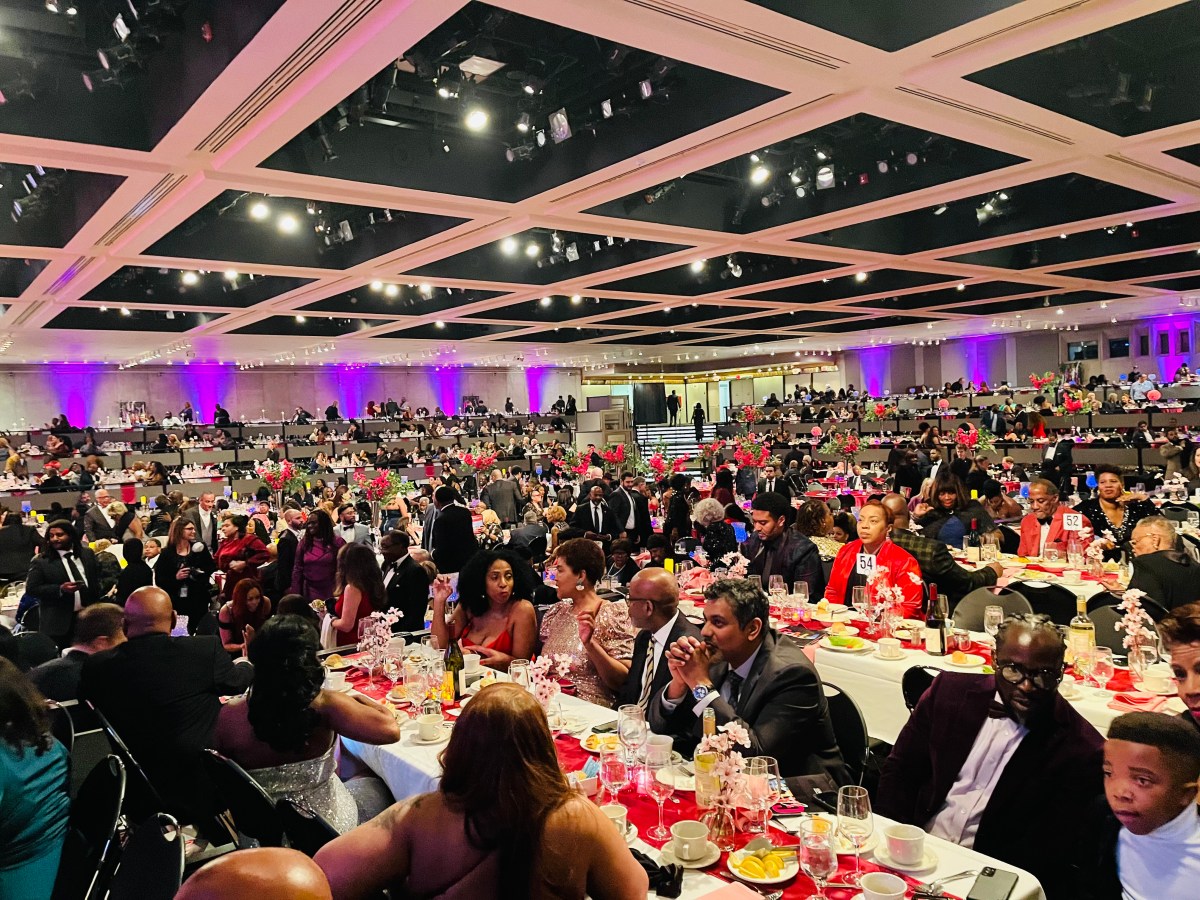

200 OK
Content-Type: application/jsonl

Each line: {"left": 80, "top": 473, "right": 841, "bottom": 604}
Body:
{"left": 215, "top": 616, "right": 400, "bottom": 833}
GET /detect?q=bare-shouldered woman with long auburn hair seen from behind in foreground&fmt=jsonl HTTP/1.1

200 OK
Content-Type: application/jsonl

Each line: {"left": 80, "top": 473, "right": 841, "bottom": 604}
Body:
{"left": 316, "top": 684, "right": 648, "bottom": 900}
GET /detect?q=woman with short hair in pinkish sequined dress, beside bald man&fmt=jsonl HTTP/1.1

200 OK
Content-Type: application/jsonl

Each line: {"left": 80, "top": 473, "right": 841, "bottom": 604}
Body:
{"left": 541, "top": 538, "right": 637, "bottom": 707}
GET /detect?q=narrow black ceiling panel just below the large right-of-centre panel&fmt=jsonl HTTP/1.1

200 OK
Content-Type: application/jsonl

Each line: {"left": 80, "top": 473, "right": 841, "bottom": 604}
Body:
{"left": 602, "top": 253, "right": 845, "bottom": 296}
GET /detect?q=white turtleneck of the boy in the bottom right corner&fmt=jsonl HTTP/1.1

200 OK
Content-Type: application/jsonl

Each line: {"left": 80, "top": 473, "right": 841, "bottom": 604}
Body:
{"left": 1117, "top": 803, "right": 1200, "bottom": 900}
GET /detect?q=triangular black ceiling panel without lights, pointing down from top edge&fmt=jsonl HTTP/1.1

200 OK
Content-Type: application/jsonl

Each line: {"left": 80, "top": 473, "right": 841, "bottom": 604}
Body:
{"left": 750, "top": 0, "right": 1020, "bottom": 50}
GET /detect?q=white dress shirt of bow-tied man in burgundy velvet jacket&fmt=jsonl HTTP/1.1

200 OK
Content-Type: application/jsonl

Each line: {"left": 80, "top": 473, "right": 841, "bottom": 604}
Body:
{"left": 925, "top": 692, "right": 1030, "bottom": 847}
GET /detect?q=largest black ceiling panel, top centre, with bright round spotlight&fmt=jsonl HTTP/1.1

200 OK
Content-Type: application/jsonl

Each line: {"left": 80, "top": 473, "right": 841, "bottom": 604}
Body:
{"left": 266, "top": 2, "right": 781, "bottom": 202}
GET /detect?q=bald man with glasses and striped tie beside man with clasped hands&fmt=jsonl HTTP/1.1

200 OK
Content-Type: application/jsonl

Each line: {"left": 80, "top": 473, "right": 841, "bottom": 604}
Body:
{"left": 617, "top": 569, "right": 700, "bottom": 709}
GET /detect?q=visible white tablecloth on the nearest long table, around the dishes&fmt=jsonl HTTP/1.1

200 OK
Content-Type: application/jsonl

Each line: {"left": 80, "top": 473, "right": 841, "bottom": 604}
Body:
{"left": 342, "top": 696, "right": 1045, "bottom": 900}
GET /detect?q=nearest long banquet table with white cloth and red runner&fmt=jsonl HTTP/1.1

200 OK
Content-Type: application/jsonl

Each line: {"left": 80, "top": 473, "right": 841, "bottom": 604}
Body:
{"left": 342, "top": 689, "right": 1045, "bottom": 900}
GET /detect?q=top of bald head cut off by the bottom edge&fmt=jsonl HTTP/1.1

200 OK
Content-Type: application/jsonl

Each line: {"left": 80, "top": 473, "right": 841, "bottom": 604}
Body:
{"left": 175, "top": 847, "right": 332, "bottom": 900}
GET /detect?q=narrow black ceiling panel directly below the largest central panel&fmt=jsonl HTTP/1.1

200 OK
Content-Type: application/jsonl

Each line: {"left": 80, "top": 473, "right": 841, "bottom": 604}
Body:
{"left": 412, "top": 228, "right": 685, "bottom": 284}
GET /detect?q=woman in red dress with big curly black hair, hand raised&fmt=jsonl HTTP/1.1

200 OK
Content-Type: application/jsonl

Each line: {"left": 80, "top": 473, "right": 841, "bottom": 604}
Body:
{"left": 431, "top": 548, "right": 538, "bottom": 672}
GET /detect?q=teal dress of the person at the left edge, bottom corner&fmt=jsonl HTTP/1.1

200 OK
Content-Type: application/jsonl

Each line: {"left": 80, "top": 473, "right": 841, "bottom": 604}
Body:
{"left": 0, "top": 740, "right": 71, "bottom": 900}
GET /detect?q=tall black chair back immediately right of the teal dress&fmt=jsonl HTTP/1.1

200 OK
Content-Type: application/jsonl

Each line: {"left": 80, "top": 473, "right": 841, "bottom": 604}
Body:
{"left": 50, "top": 755, "right": 125, "bottom": 900}
